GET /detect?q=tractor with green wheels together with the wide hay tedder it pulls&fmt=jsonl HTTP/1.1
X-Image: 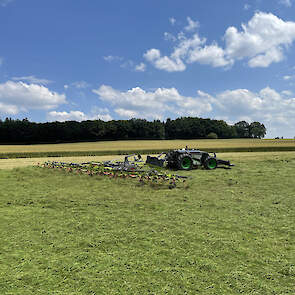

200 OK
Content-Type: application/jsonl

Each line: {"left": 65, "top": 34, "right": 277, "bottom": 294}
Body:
{"left": 39, "top": 147, "right": 234, "bottom": 189}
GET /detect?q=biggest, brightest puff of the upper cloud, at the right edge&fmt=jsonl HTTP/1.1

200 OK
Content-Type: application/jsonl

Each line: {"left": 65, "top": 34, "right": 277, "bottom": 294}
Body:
{"left": 224, "top": 12, "right": 295, "bottom": 67}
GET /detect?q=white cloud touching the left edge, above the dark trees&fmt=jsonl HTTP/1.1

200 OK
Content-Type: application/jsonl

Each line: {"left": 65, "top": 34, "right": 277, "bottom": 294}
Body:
{"left": 0, "top": 81, "right": 66, "bottom": 114}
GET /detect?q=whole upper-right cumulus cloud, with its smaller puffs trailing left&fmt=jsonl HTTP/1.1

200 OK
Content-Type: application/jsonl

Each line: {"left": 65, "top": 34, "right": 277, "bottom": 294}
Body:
{"left": 144, "top": 12, "right": 295, "bottom": 72}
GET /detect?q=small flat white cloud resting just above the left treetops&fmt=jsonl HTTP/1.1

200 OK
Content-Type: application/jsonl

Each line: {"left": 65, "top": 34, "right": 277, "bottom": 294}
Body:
{"left": 47, "top": 109, "right": 112, "bottom": 122}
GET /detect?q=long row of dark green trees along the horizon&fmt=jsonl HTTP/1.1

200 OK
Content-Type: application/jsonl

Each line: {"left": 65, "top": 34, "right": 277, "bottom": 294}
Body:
{"left": 0, "top": 117, "right": 266, "bottom": 144}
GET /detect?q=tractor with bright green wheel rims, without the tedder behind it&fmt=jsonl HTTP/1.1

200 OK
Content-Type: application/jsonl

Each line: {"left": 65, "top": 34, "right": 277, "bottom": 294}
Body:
{"left": 146, "top": 147, "right": 234, "bottom": 170}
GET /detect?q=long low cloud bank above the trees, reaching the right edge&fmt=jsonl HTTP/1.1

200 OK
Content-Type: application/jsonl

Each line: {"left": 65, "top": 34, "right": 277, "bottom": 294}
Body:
{"left": 93, "top": 85, "right": 295, "bottom": 136}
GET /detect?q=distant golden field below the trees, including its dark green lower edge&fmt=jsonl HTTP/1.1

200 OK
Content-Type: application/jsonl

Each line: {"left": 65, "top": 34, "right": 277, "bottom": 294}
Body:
{"left": 0, "top": 139, "right": 295, "bottom": 158}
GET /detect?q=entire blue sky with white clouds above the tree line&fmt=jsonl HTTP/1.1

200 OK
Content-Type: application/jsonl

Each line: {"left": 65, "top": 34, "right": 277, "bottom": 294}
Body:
{"left": 0, "top": 0, "right": 295, "bottom": 138}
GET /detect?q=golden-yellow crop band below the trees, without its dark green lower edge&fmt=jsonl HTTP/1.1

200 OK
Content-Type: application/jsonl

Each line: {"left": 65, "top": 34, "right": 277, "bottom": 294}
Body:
{"left": 0, "top": 139, "right": 295, "bottom": 155}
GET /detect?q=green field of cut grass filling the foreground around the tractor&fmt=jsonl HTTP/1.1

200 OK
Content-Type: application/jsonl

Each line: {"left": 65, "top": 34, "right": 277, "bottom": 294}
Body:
{"left": 0, "top": 152, "right": 295, "bottom": 295}
